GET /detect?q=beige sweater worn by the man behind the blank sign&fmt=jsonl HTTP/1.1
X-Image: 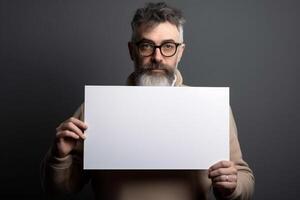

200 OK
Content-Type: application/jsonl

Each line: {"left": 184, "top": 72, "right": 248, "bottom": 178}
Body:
{"left": 41, "top": 71, "right": 254, "bottom": 200}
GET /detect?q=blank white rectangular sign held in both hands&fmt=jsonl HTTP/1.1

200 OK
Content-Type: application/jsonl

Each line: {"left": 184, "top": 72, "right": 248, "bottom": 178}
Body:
{"left": 84, "top": 86, "right": 229, "bottom": 169}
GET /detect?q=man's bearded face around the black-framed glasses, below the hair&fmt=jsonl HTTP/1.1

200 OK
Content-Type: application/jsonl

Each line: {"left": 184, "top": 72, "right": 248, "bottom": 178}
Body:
{"left": 129, "top": 22, "right": 184, "bottom": 85}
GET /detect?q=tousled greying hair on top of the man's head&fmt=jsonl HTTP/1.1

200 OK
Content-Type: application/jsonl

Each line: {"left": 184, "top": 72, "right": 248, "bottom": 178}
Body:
{"left": 131, "top": 2, "right": 185, "bottom": 42}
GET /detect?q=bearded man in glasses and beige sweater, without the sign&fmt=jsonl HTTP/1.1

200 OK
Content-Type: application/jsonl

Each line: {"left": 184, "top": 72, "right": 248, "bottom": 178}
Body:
{"left": 42, "top": 3, "right": 254, "bottom": 200}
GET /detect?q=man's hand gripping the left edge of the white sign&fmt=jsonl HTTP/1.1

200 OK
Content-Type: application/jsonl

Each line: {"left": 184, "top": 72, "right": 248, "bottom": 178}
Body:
{"left": 55, "top": 117, "right": 87, "bottom": 158}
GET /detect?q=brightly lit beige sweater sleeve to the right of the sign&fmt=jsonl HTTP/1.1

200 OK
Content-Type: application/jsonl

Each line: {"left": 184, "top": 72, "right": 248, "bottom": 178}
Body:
{"left": 216, "top": 110, "right": 254, "bottom": 200}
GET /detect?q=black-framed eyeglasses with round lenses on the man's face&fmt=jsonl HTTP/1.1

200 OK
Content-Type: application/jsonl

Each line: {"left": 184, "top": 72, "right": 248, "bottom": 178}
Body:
{"left": 135, "top": 41, "right": 182, "bottom": 57}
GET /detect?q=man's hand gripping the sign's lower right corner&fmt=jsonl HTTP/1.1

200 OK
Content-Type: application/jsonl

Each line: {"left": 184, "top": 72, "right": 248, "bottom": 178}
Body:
{"left": 208, "top": 161, "right": 237, "bottom": 197}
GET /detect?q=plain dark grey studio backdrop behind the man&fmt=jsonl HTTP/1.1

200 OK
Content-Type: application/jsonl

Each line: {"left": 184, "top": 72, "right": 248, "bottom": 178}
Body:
{"left": 0, "top": 0, "right": 300, "bottom": 199}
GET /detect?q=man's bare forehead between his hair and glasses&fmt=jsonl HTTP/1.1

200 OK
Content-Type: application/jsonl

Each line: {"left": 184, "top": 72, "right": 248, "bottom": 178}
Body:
{"left": 137, "top": 22, "right": 180, "bottom": 44}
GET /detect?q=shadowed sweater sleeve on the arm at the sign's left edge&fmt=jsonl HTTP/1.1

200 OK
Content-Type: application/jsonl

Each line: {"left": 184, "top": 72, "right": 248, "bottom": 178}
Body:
{"left": 41, "top": 105, "right": 88, "bottom": 196}
